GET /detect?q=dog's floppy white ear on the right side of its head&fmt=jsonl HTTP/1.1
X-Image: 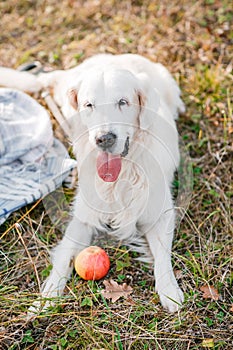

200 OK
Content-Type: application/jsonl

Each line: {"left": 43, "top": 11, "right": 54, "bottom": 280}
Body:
{"left": 137, "top": 73, "right": 159, "bottom": 129}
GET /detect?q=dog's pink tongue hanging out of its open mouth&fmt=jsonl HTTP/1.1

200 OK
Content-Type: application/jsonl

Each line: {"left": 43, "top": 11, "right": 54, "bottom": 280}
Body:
{"left": 96, "top": 152, "right": 121, "bottom": 182}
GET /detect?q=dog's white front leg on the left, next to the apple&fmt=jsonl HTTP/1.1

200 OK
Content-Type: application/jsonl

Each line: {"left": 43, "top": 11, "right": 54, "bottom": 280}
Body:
{"left": 28, "top": 217, "right": 92, "bottom": 316}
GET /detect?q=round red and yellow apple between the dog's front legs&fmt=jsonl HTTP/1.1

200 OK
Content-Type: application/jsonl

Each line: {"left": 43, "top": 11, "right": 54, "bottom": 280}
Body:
{"left": 74, "top": 246, "right": 110, "bottom": 281}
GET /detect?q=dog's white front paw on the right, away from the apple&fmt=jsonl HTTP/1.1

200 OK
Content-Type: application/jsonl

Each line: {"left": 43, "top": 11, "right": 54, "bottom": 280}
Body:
{"left": 158, "top": 285, "right": 184, "bottom": 313}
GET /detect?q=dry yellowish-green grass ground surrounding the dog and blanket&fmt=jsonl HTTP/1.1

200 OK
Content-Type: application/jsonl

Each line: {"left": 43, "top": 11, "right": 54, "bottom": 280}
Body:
{"left": 0, "top": 0, "right": 233, "bottom": 350}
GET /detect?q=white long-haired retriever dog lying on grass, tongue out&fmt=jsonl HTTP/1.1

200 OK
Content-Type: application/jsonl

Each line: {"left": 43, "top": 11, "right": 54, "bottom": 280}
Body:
{"left": 0, "top": 54, "right": 184, "bottom": 312}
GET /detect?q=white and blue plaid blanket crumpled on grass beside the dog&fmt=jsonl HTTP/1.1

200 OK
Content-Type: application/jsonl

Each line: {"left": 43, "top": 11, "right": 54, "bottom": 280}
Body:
{"left": 0, "top": 88, "right": 76, "bottom": 225}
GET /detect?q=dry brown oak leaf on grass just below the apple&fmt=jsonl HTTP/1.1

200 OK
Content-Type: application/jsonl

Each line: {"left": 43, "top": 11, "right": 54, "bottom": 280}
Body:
{"left": 101, "top": 279, "right": 133, "bottom": 303}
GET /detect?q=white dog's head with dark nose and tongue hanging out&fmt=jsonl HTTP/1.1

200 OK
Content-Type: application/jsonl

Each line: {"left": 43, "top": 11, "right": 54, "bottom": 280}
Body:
{"left": 68, "top": 70, "right": 159, "bottom": 182}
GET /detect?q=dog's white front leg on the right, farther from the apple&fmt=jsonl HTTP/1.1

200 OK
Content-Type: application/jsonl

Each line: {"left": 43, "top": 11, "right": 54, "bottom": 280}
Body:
{"left": 146, "top": 210, "right": 184, "bottom": 312}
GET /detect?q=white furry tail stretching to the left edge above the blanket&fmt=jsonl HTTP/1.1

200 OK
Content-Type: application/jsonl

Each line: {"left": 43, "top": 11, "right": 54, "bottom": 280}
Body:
{"left": 0, "top": 67, "right": 42, "bottom": 92}
